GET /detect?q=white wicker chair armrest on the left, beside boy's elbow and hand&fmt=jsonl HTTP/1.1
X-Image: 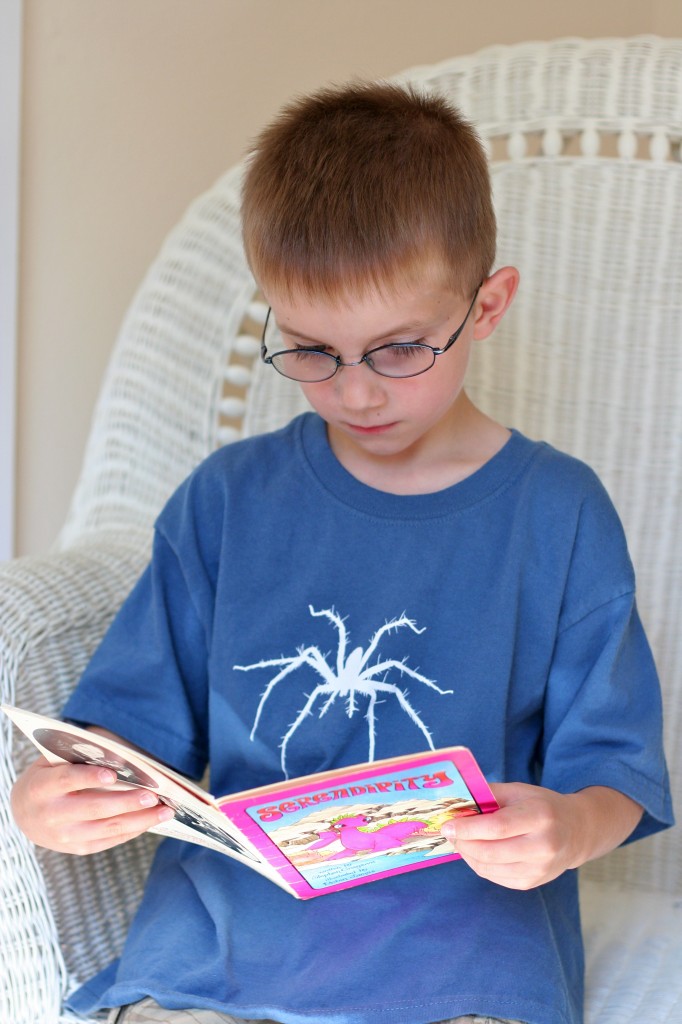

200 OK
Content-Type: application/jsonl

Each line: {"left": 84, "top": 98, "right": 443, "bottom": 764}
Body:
{"left": 0, "top": 534, "right": 154, "bottom": 1024}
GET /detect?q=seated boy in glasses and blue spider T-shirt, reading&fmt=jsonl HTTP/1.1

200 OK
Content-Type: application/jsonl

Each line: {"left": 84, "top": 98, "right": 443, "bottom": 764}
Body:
{"left": 13, "top": 84, "right": 672, "bottom": 1024}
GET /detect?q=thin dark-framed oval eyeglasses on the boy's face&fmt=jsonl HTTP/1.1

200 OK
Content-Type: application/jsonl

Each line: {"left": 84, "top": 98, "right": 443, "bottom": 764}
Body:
{"left": 260, "top": 282, "right": 482, "bottom": 384}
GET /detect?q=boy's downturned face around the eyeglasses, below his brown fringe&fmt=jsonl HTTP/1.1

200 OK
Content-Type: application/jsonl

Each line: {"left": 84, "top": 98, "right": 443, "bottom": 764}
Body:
{"left": 268, "top": 283, "right": 478, "bottom": 490}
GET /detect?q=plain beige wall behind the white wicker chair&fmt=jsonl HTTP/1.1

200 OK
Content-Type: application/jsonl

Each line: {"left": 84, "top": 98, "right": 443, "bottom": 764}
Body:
{"left": 16, "top": 0, "right": 682, "bottom": 554}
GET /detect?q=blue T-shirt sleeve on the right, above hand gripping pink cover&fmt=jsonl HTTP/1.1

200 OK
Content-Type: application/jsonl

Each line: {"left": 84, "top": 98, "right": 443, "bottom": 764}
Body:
{"left": 542, "top": 592, "right": 673, "bottom": 841}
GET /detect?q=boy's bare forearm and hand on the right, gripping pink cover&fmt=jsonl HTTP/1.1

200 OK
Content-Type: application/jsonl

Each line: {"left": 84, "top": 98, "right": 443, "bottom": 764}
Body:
{"left": 442, "top": 782, "right": 642, "bottom": 889}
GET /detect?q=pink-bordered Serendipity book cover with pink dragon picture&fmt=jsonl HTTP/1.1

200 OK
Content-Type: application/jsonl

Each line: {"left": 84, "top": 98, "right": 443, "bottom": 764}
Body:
{"left": 217, "top": 746, "right": 498, "bottom": 899}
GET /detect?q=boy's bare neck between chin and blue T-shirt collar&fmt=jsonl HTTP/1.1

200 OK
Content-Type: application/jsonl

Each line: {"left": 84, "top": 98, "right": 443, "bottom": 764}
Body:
{"left": 327, "top": 392, "right": 511, "bottom": 495}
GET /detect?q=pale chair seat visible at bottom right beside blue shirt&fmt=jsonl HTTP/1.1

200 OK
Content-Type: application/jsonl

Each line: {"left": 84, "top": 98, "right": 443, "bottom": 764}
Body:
{"left": 581, "top": 881, "right": 682, "bottom": 1024}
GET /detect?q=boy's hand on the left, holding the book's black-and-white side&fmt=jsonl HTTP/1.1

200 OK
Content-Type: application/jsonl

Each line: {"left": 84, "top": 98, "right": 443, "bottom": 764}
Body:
{"left": 11, "top": 757, "right": 173, "bottom": 855}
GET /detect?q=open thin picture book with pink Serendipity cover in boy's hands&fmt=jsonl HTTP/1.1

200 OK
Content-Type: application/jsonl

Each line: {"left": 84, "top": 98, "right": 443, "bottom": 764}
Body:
{"left": 0, "top": 705, "right": 498, "bottom": 899}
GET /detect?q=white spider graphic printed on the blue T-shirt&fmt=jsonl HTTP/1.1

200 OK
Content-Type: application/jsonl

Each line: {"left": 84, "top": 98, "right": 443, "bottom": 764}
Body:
{"left": 233, "top": 604, "right": 453, "bottom": 778}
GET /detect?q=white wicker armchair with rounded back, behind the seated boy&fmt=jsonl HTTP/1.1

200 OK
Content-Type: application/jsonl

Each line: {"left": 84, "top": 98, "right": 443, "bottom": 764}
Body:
{"left": 0, "top": 37, "right": 682, "bottom": 1024}
